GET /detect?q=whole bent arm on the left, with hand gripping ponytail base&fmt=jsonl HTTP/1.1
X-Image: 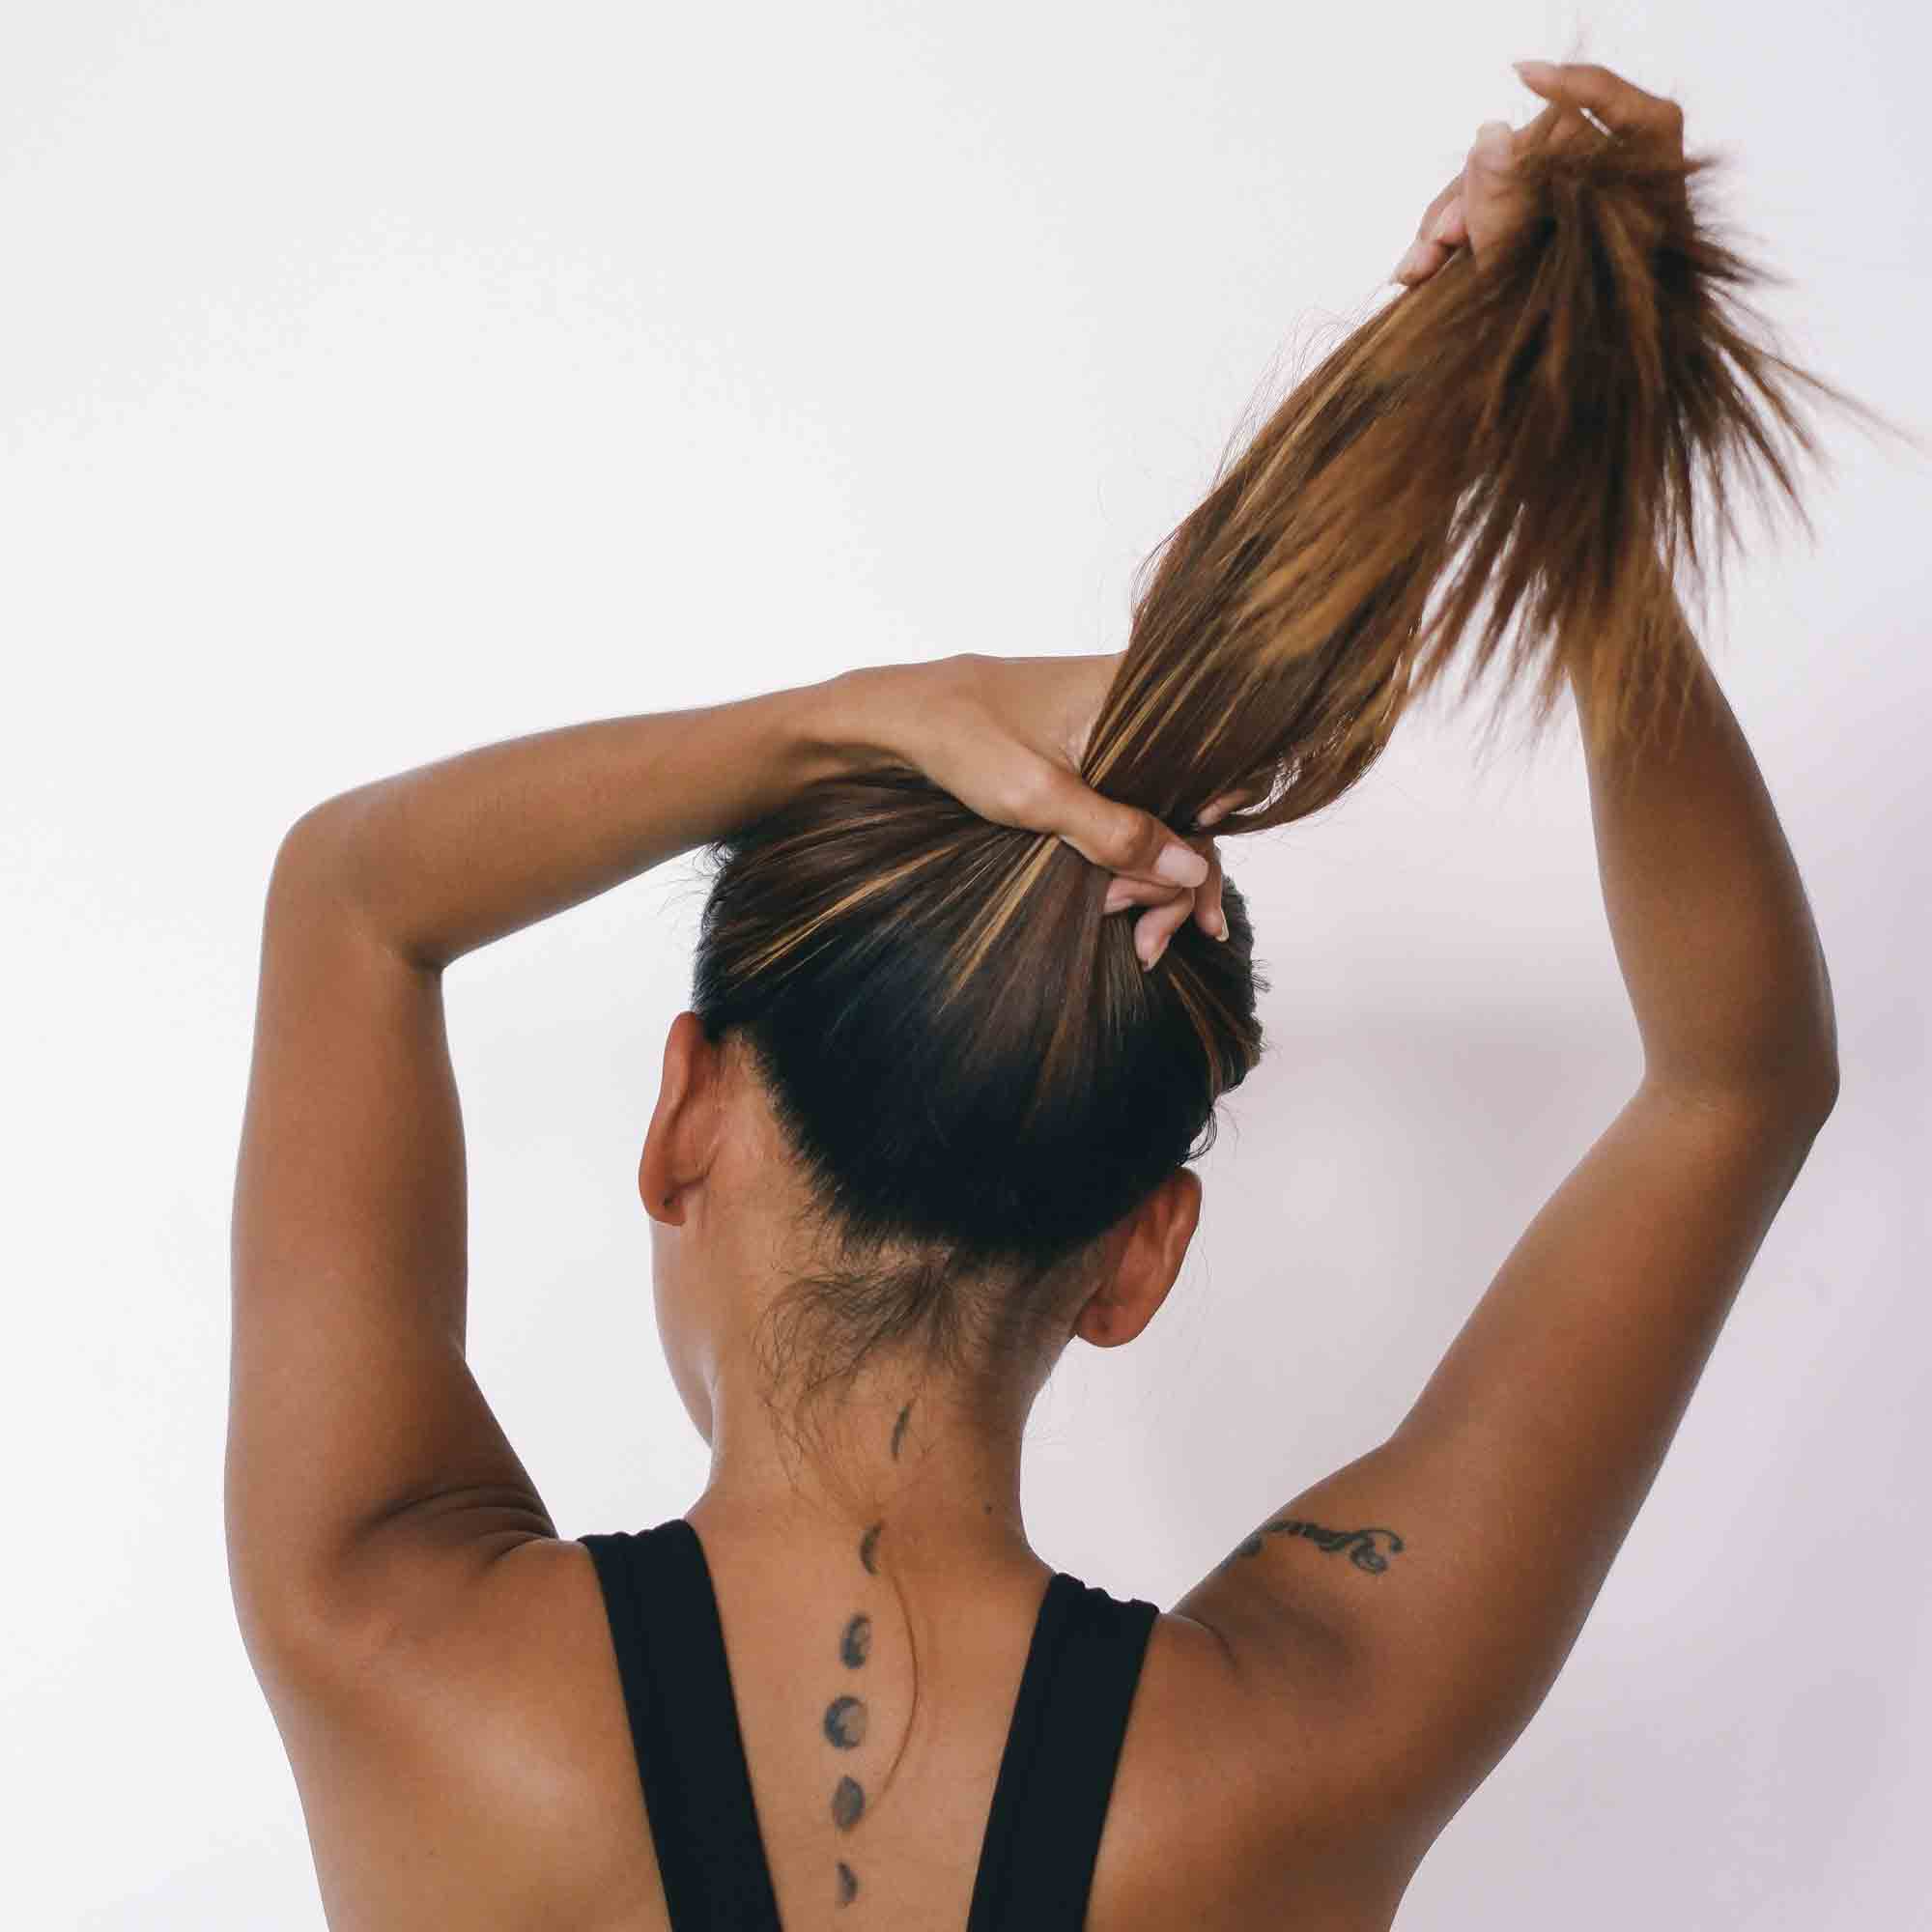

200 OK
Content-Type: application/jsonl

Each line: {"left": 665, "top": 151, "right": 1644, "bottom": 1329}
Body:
{"left": 226, "top": 659, "right": 1219, "bottom": 1673}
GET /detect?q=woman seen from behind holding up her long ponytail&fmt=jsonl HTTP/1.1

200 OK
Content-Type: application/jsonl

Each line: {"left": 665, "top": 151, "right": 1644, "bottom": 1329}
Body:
{"left": 226, "top": 64, "right": 1835, "bottom": 1932}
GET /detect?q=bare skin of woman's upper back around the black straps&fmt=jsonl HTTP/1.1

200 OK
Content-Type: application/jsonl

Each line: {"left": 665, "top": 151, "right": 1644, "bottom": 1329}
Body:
{"left": 284, "top": 1538, "right": 1401, "bottom": 1932}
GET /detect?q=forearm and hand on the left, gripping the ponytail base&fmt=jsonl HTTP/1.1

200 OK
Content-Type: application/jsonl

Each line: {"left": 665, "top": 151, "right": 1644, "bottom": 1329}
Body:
{"left": 305, "top": 655, "right": 1209, "bottom": 966}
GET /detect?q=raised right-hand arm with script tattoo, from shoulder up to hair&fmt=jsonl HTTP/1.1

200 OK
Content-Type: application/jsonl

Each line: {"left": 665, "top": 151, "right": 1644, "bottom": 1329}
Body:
{"left": 1177, "top": 576, "right": 1837, "bottom": 1872}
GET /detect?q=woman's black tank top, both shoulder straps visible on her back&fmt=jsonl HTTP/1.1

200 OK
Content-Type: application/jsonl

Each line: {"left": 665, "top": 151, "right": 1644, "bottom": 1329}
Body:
{"left": 578, "top": 1517, "right": 1159, "bottom": 1932}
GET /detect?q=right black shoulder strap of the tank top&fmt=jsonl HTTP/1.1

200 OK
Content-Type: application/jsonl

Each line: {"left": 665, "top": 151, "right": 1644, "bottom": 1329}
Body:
{"left": 966, "top": 1571, "right": 1159, "bottom": 1932}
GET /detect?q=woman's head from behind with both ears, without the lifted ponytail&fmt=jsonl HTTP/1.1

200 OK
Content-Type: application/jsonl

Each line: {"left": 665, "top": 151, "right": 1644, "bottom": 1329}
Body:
{"left": 639, "top": 775, "right": 1260, "bottom": 1484}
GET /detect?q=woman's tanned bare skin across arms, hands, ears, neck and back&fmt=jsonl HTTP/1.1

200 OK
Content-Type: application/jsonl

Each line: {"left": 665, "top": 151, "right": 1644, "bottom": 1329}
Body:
{"left": 226, "top": 52, "right": 1837, "bottom": 1932}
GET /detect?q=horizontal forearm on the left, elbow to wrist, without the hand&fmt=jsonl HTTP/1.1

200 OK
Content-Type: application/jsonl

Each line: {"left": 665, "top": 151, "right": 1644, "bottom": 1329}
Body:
{"left": 292, "top": 680, "right": 869, "bottom": 968}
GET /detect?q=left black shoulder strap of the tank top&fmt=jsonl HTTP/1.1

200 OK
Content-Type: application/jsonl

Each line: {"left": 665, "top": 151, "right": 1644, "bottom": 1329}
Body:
{"left": 578, "top": 1517, "right": 781, "bottom": 1932}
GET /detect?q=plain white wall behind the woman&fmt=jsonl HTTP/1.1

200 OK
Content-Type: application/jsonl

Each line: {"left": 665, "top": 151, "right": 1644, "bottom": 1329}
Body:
{"left": 0, "top": 0, "right": 1932, "bottom": 1932}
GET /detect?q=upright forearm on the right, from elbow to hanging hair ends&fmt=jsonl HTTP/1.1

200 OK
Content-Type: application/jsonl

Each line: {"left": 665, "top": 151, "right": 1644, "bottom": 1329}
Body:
{"left": 1571, "top": 576, "right": 1837, "bottom": 1094}
